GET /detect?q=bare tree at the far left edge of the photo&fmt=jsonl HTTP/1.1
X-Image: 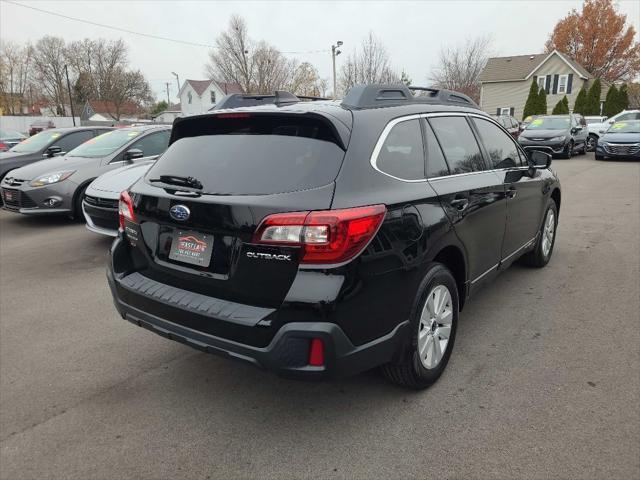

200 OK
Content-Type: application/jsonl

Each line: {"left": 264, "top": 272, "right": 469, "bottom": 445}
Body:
{"left": 0, "top": 41, "right": 32, "bottom": 115}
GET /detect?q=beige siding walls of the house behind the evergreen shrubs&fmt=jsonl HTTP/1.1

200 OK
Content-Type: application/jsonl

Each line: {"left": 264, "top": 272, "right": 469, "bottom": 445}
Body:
{"left": 480, "top": 55, "right": 585, "bottom": 120}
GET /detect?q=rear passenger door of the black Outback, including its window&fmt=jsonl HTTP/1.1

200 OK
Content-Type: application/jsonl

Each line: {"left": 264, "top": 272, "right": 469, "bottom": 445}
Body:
{"left": 427, "top": 115, "right": 507, "bottom": 289}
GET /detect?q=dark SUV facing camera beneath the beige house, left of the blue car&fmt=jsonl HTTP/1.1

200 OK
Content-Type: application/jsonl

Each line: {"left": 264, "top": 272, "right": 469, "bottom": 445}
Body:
{"left": 518, "top": 113, "right": 589, "bottom": 158}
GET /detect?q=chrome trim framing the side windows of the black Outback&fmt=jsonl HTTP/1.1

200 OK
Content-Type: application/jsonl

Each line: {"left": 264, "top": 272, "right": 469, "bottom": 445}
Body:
{"left": 369, "top": 112, "right": 529, "bottom": 183}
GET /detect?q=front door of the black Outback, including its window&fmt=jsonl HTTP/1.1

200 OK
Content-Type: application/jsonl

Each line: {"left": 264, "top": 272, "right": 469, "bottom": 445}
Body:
{"left": 472, "top": 117, "right": 545, "bottom": 262}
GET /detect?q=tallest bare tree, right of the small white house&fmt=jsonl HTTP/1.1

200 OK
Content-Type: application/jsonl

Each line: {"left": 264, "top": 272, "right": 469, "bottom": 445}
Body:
{"left": 205, "top": 15, "right": 298, "bottom": 93}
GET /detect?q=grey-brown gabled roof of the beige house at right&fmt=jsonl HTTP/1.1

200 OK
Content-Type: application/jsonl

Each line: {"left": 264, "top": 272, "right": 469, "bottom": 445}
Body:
{"left": 479, "top": 50, "right": 593, "bottom": 82}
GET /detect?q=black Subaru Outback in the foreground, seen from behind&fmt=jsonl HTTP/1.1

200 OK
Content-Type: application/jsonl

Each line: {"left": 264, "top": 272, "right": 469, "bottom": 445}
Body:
{"left": 107, "top": 85, "right": 560, "bottom": 388}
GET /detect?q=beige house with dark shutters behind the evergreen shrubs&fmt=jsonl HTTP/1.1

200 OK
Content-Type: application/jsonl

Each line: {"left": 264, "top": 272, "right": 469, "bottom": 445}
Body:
{"left": 479, "top": 50, "right": 607, "bottom": 120}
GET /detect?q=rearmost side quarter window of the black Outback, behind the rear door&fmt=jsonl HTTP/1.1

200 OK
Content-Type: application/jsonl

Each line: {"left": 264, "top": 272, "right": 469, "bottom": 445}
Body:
{"left": 376, "top": 119, "right": 424, "bottom": 180}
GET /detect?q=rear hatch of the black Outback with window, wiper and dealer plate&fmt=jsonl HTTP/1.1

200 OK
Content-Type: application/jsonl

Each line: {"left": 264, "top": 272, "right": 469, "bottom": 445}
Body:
{"left": 125, "top": 112, "right": 345, "bottom": 307}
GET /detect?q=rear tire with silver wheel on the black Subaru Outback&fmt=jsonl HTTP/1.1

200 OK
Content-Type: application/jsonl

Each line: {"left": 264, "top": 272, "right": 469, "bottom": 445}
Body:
{"left": 381, "top": 263, "right": 460, "bottom": 390}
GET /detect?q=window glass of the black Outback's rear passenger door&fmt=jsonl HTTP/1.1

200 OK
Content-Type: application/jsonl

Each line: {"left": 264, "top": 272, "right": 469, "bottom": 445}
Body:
{"left": 429, "top": 117, "right": 485, "bottom": 175}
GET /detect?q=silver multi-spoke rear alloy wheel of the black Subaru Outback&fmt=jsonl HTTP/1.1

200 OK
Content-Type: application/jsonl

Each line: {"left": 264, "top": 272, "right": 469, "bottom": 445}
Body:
{"left": 418, "top": 285, "right": 453, "bottom": 369}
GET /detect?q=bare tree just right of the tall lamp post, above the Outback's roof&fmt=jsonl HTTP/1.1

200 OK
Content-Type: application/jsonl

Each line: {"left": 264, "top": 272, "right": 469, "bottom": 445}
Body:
{"left": 340, "top": 32, "right": 400, "bottom": 92}
